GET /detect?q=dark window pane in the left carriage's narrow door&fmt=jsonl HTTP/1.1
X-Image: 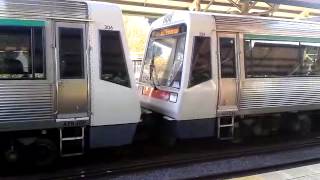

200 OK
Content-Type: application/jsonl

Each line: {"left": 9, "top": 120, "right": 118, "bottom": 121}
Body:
{"left": 59, "top": 27, "right": 84, "bottom": 79}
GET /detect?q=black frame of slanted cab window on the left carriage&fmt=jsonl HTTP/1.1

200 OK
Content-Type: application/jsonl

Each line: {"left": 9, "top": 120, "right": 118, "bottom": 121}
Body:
{"left": 98, "top": 29, "right": 132, "bottom": 88}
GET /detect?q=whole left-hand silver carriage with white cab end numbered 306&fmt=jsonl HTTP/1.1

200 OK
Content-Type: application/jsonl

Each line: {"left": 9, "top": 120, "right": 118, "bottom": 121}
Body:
{"left": 0, "top": 0, "right": 140, "bottom": 165}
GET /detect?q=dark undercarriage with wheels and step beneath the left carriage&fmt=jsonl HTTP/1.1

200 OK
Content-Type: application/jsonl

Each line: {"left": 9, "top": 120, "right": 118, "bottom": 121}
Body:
{"left": 0, "top": 127, "right": 88, "bottom": 167}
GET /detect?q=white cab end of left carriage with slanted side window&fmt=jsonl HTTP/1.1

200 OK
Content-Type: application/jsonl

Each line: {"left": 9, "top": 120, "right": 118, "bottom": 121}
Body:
{"left": 88, "top": 2, "right": 140, "bottom": 148}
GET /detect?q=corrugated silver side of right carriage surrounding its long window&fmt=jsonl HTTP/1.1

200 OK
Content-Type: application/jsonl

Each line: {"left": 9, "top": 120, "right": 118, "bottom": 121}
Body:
{"left": 215, "top": 15, "right": 320, "bottom": 115}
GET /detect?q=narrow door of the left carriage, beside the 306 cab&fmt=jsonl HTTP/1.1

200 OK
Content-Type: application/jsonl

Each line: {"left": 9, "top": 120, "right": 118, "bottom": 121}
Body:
{"left": 56, "top": 22, "right": 88, "bottom": 119}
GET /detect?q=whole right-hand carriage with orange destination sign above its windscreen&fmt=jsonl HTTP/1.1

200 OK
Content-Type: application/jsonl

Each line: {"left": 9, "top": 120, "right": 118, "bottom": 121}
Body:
{"left": 139, "top": 12, "right": 320, "bottom": 141}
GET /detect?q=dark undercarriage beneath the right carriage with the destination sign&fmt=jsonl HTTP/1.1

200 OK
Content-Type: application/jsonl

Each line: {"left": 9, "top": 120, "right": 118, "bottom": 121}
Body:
{"left": 143, "top": 111, "right": 320, "bottom": 146}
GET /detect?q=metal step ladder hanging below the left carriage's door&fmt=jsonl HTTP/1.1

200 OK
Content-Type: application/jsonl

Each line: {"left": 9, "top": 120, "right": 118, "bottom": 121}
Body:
{"left": 60, "top": 127, "right": 85, "bottom": 157}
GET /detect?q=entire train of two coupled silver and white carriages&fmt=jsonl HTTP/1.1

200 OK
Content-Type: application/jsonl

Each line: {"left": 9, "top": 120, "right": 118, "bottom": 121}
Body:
{"left": 0, "top": 0, "right": 320, "bottom": 166}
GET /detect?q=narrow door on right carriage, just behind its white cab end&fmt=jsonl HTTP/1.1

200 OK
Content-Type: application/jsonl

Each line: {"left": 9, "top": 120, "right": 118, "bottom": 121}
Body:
{"left": 218, "top": 33, "right": 239, "bottom": 113}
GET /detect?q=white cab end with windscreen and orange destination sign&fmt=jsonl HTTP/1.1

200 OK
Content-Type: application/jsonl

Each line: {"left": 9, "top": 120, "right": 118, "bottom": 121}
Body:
{"left": 139, "top": 12, "right": 216, "bottom": 141}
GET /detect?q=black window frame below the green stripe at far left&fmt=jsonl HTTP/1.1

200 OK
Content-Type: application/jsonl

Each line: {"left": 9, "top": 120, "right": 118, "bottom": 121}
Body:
{"left": 0, "top": 25, "right": 47, "bottom": 81}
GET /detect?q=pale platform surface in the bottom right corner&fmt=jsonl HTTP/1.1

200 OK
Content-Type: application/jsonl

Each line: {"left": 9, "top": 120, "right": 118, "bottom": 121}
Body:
{"left": 232, "top": 163, "right": 320, "bottom": 180}
